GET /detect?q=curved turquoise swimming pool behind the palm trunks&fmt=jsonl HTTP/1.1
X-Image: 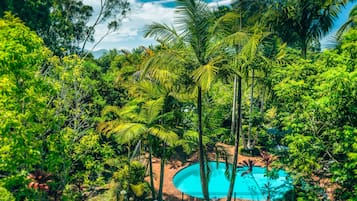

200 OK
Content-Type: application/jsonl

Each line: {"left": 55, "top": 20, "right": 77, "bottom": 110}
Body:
{"left": 173, "top": 162, "right": 292, "bottom": 200}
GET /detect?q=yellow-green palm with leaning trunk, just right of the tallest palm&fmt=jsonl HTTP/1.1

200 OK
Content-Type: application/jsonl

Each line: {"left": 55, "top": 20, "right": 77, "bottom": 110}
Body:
{"left": 213, "top": 9, "right": 268, "bottom": 200}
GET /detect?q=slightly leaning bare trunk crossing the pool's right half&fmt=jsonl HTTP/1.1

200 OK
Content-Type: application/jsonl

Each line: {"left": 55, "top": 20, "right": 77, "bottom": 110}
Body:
{"left": 227, "top": 69, "right": 242, "bottom": 201}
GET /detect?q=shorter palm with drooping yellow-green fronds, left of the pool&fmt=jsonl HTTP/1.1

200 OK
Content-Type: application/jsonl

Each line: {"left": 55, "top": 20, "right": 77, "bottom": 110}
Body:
{"left": 98, "top": 90, "right": 178, "bottom": 198}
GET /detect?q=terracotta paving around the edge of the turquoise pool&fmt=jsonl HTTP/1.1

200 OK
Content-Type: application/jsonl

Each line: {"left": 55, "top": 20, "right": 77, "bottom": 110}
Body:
{"left": 146, "top": 143, "right": 263, "bottom": 201}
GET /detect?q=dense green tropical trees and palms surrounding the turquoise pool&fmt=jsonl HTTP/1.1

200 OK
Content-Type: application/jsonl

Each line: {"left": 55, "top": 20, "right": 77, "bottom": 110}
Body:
{"left": 0, "top": 0, "right": 357, "bottom": 201}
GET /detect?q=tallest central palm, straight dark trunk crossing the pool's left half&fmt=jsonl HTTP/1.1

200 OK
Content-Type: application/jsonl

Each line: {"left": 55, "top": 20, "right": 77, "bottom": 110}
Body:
{"left": 146, "top": 0, "right": 219, "bottom": 201}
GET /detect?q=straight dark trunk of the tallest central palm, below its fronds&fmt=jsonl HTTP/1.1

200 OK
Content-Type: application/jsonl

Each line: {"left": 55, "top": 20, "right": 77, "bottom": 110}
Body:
{"left": 197, "top": 87, "right": 209, "bottom": 201}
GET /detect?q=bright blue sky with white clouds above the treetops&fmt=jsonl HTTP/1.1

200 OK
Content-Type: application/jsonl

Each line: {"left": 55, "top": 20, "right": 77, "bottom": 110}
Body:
{"left": 84, "top": 0, "right": 357, "bottom": 50}
